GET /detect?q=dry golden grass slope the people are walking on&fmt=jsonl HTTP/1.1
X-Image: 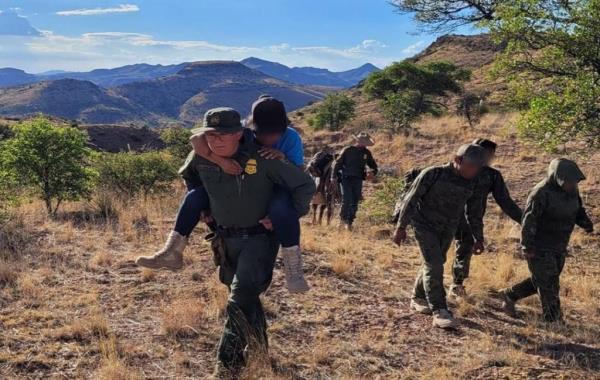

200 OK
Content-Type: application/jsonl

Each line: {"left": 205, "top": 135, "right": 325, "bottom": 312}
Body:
{"left": 0, "top": 111, "right": 600, "bottom": 379}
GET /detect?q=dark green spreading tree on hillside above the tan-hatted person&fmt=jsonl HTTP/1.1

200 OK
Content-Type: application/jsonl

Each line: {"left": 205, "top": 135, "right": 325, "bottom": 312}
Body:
{"left": 363, "top": 61, "right": 470, "bottom": 130}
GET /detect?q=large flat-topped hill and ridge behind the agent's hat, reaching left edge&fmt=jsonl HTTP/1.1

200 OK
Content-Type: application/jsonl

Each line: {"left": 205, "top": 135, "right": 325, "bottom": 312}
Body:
{"left": 0, "top": 61, "right": 325, "bottom": 126}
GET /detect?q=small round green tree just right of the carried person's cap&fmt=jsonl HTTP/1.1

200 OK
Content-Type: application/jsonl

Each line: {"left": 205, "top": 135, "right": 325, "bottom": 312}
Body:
{"left": 311, "top": 93, "right": 356, "bottom": 131}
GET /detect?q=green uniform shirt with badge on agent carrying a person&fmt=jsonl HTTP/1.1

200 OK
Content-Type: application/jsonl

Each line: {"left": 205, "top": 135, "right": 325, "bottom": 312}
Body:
{"left": 180, "top": 143, "right": 315, "bottom": 228}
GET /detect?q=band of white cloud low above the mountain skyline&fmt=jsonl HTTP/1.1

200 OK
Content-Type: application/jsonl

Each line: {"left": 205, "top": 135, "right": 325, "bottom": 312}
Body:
{"left": 0, "top": 31, "right": 398, "bottom": 72}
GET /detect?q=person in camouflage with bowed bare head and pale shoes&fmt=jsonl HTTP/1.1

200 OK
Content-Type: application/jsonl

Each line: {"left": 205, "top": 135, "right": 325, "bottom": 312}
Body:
{"left": 393, "top": 144, "right": 485, "bottom": 328}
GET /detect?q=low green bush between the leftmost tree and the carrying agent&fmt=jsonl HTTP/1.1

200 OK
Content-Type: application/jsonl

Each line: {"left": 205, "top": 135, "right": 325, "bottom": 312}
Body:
{"left": 95, "top": 152, "right": 177, "bottom": 198}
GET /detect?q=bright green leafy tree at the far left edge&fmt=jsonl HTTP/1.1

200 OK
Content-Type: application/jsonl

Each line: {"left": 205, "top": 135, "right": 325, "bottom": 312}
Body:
{"left": 0, "top": 118, "right": 94, "bottom": 215}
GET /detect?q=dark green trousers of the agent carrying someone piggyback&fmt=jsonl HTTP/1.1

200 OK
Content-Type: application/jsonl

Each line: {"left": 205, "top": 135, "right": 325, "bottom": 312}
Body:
{"left": 218, "top": 235, "right": 279, "bottom": 368}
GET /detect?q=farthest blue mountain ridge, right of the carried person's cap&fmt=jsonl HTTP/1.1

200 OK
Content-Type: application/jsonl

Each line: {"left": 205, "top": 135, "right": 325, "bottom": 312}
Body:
{"left": 241, "top": 57, "right": 379, "bottom": 88}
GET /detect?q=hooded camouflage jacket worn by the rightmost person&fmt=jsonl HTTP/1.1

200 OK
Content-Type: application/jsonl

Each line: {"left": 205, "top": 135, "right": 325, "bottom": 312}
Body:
{"left": 521, "top": 160, "right": 594, "bottom": 252}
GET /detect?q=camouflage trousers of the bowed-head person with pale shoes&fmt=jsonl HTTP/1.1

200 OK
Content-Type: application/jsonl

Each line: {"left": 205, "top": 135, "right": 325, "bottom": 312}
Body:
{"left": 412, "top": 225, "right": 453, "bottom": 311}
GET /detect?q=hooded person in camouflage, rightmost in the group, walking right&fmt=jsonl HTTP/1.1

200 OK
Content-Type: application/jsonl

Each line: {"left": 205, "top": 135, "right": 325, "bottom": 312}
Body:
{"left": 501, "top": 158, "right": 594, "bottom": 322}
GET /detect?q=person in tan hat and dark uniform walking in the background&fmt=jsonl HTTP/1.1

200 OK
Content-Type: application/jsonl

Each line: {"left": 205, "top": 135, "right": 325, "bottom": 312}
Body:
{"left": 331, "top": 132, "right": 378, "bottom": 230}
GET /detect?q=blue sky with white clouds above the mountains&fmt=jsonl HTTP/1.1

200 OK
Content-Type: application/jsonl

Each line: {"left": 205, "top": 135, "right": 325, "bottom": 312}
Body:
{"left": 0, "top": 0, "right": 458, "bottom": 72}
